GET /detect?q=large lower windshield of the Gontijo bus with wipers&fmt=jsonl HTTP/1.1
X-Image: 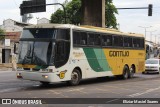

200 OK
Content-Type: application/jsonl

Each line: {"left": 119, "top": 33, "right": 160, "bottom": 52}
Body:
{"left": 18, "top": 41, "right": 55, "bottom": 65}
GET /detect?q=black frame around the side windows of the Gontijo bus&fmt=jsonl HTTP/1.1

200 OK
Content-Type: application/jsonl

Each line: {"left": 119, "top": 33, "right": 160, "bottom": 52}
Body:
{"left": 72, "top": 29, "right": 145, "bottom": 50}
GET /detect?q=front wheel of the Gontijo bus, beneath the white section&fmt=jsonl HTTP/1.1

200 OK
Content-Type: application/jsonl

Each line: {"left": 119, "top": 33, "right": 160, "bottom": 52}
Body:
{"left": 68, "top": 69, "right": 81, "bottom": 86}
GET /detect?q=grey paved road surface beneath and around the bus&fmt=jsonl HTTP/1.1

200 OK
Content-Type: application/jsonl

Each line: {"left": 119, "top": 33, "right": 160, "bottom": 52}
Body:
{"left": 0, "top": 71, "right": 160, "bottom": 107}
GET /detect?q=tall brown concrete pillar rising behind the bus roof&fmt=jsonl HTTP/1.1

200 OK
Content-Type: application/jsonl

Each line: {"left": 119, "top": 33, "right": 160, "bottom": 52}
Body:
{"left": 82, "top": 0, "right": 105, "bottom": 27}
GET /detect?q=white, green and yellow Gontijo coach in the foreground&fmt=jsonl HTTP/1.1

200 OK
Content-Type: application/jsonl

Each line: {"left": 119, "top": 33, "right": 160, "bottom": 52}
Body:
{"left": 17, "top": 24, "right": 146, "bottom": 85}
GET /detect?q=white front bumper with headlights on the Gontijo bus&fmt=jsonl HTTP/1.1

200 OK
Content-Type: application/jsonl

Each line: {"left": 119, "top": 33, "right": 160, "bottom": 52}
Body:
{"left": 17, "top": 71, "right": 60, "bottom": 82}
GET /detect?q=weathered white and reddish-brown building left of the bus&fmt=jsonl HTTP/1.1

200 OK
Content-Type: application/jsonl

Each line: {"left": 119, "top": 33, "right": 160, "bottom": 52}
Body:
{"left": 0, "top": 19, "right": 29, "bottom": 68}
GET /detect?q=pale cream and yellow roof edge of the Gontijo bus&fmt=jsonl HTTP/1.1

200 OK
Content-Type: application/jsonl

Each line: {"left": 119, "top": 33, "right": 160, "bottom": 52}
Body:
{"left": 25, "top": 24, "right": 144, "bottom": 37}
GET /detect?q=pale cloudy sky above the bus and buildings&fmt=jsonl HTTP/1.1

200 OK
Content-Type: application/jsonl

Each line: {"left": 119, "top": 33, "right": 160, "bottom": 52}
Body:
{"left": 0, "top": 0, "right": 160, "bottom": 43}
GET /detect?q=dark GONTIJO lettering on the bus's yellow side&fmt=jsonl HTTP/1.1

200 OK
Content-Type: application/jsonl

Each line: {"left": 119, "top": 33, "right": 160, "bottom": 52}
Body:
{"left": 109, "top": 51, "right": 129, "bottom": 57}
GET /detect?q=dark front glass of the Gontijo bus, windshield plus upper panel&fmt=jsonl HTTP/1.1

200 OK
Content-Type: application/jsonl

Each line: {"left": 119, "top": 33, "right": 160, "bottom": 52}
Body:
{"left": 18, "top": 28, "right": 68, "bottom": 65}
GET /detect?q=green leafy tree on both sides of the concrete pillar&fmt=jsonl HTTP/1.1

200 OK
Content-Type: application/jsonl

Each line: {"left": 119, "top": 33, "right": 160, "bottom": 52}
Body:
{"left": 51, "top": 0, "right": 118, "bottom": 28}
